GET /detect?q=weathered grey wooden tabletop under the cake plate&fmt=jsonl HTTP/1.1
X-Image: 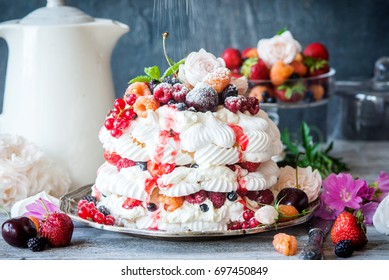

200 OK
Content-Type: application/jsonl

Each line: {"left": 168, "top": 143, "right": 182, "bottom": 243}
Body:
{"left": 0, "top": 141, "right": 389, "bottom": 260}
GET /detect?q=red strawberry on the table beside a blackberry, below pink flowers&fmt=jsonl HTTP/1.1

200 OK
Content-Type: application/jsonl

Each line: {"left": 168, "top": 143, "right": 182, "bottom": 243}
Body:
{"left": 331, "top": 211, "right": 367, "bottom": 249}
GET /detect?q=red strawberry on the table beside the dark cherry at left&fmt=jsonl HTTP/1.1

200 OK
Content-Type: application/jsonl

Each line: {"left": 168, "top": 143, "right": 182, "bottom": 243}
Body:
{"left": 39, "top": 213, "right": 74, "bottom": 247}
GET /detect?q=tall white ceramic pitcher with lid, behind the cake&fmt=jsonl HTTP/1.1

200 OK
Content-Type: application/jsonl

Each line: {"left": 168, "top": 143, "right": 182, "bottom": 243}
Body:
{"left": 0, "top": 0, "right": 129, "bottom": 188}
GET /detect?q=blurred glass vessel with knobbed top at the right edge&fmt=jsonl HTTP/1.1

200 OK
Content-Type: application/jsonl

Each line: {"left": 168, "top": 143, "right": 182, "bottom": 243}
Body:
{"left": 335, "top": 57, "right": 389, "bottom": 140}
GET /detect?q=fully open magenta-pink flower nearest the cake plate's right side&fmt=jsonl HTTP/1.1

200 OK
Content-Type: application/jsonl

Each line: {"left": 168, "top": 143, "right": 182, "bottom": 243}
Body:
{"left": 322, "top": 173, "right": 366, "bottom": 213}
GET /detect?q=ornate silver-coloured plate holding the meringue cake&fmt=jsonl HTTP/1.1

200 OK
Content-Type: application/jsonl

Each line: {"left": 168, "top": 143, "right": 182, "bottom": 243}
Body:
{"left": 60, "top": 185, "right": 319, "bottom": 240}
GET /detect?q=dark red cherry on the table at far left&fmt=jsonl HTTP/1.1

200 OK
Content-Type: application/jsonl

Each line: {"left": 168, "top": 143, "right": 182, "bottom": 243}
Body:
{"left": 1, "top": 217, "right": 37, "bottom": 247}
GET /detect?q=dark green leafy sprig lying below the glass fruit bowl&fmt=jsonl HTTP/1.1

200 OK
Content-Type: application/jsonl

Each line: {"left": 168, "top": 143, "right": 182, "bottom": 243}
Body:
{"left": 279, "top": 122, "right": 349, "bottom": 178}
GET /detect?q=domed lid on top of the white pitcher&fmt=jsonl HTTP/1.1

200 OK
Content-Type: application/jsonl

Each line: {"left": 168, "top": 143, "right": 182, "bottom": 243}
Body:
{"left": 19, "top": 0, "right": 94, "bottom": 25}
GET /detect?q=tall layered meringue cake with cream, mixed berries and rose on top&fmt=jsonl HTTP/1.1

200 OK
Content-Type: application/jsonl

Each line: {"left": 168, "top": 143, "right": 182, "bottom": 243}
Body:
{"left": 79, "top": 46, "right": 282, "bottom": 231}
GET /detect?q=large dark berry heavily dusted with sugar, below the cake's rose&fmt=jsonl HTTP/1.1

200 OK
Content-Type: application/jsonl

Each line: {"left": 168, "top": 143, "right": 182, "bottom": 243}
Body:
{"left": 185, "top": 83, "right": 219, "bottom": 112}
